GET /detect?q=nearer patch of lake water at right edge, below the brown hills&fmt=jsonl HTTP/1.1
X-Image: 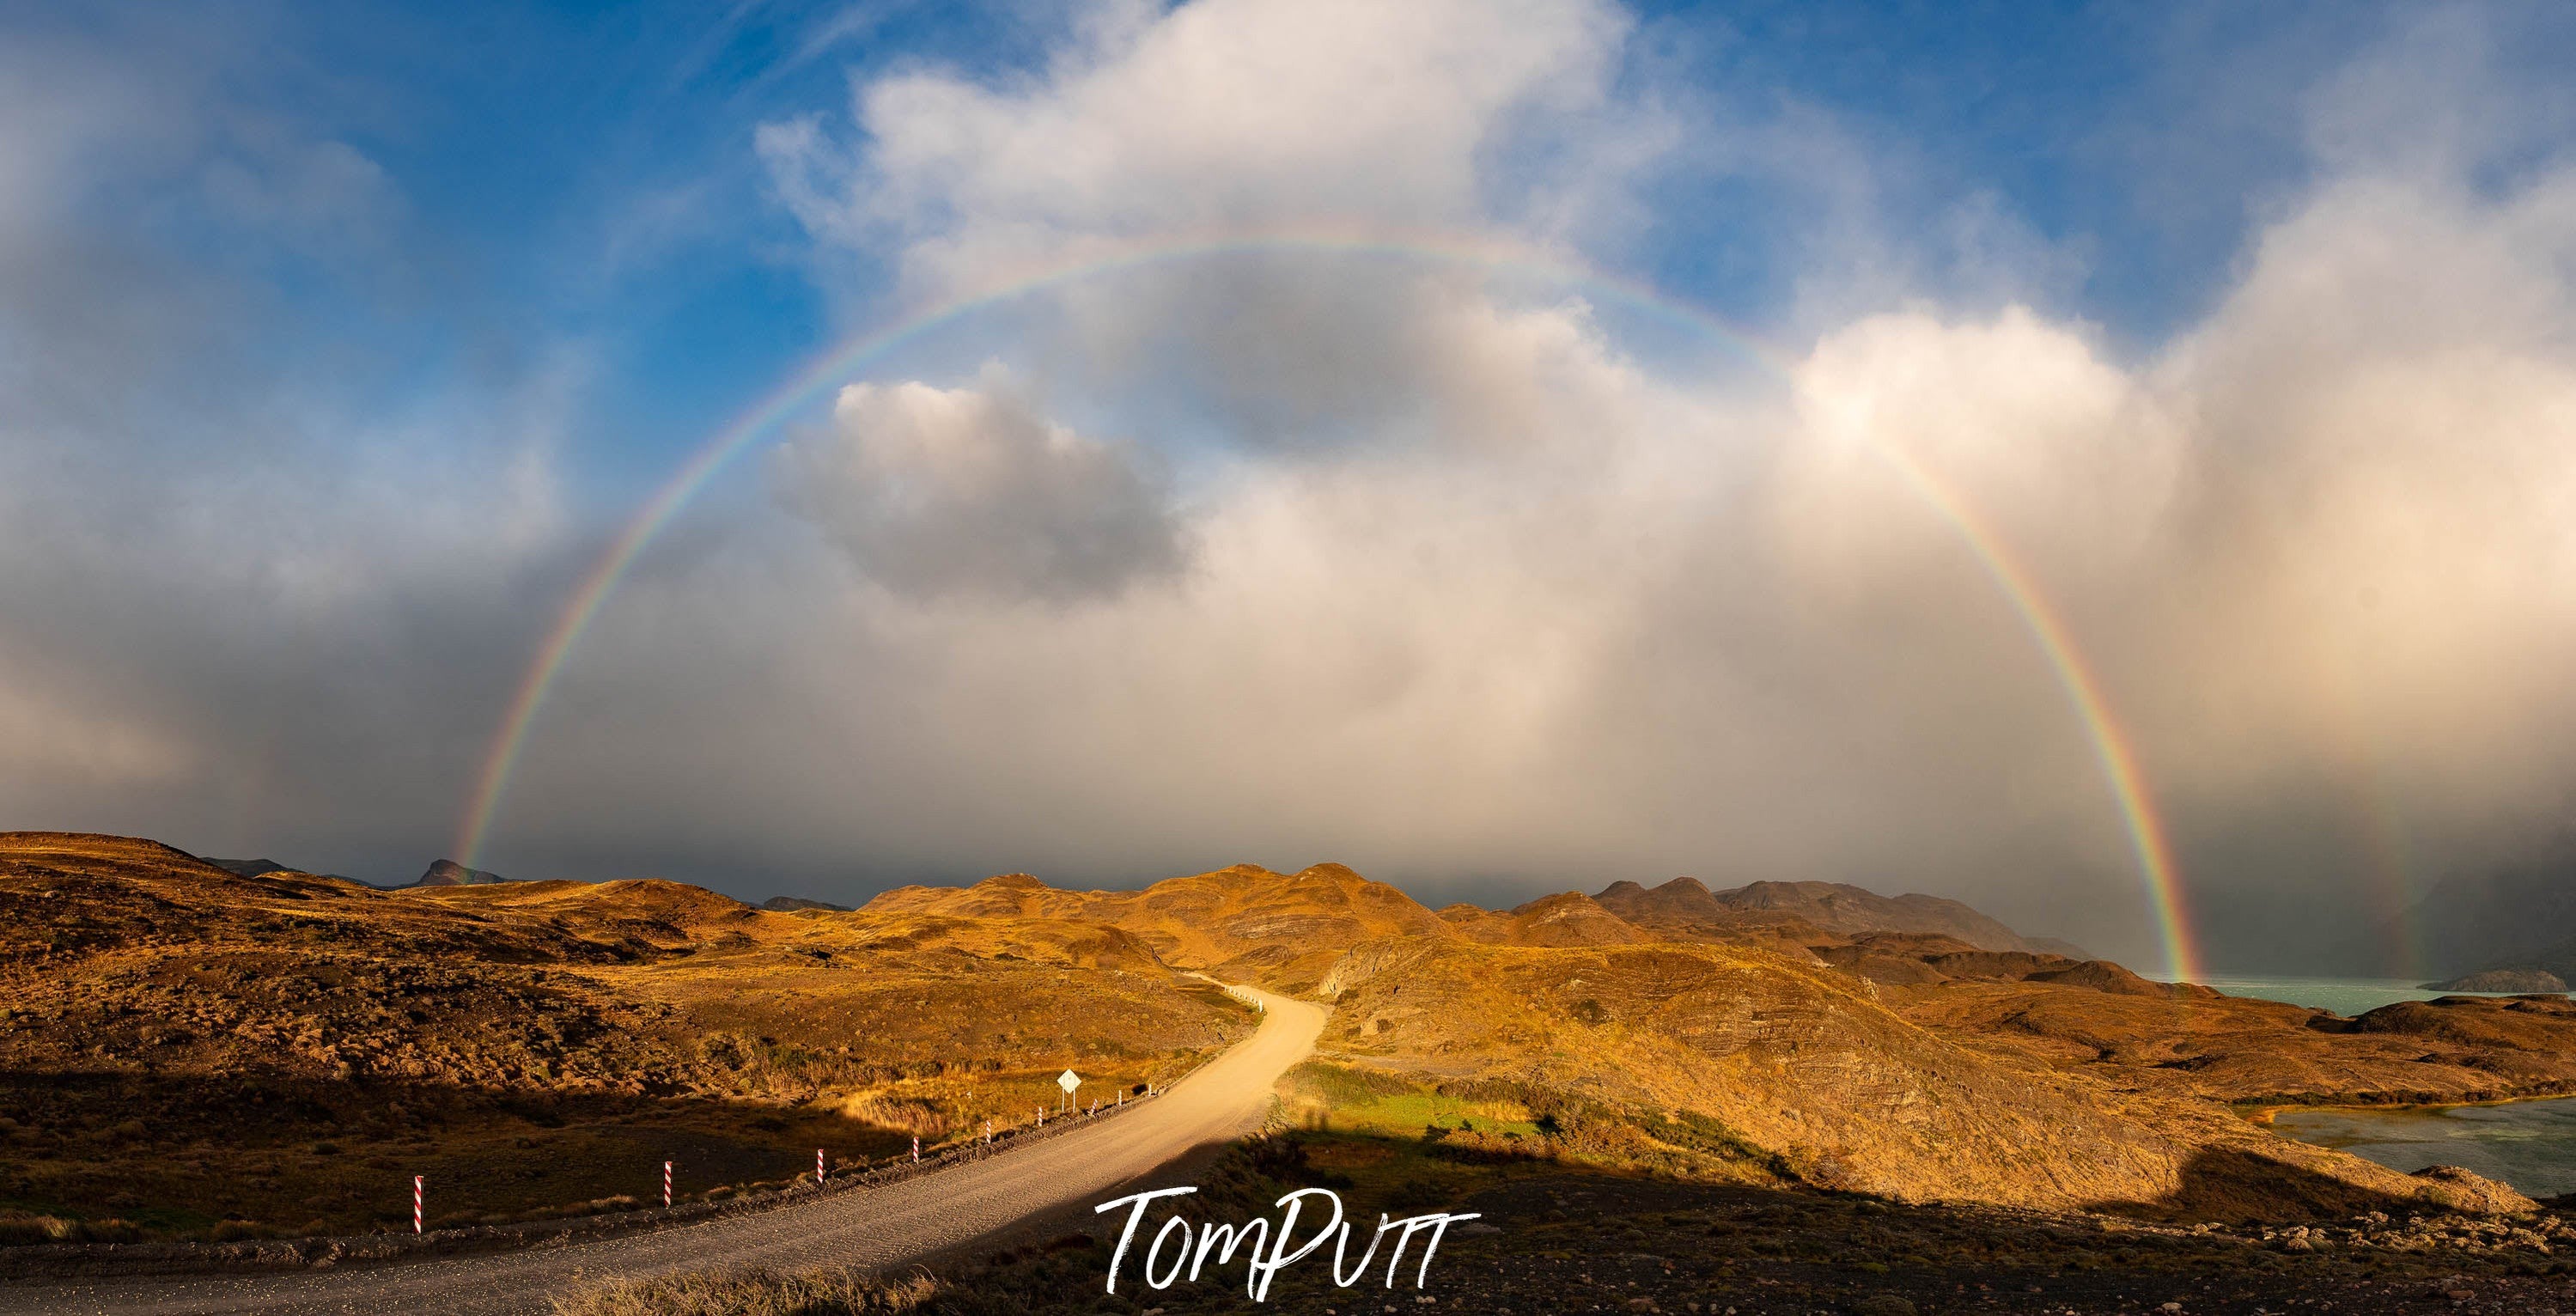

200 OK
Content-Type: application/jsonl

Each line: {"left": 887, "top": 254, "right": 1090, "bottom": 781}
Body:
{"left": 2272, "top": 1097, "right": 2576, "bottom": 1197}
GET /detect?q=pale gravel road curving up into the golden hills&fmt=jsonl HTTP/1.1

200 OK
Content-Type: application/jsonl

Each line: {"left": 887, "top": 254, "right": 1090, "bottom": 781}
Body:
{"left": 0, "top": 989, "right": 1324, "bottom": 1316}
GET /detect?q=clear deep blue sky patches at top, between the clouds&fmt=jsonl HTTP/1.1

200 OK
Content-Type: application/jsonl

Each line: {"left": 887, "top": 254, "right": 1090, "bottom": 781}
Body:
{"left": 55, "top": 3, "right": 2452, "bottom": 505}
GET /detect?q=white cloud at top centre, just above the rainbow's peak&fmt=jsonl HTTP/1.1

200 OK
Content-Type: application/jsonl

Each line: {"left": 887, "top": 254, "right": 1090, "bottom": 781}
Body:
{"left": 763, "top": 0, "right": 1625, "bottom": 274}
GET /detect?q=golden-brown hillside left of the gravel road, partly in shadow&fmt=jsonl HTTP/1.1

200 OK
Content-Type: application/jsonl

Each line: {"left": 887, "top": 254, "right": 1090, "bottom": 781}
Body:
{"left": 0, "top": 832, "right": 1250, "bottom": 1239}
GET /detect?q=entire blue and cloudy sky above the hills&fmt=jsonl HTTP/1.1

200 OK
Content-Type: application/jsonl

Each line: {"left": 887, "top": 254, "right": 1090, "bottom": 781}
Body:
{"left": 0, "top": 0, "right": 2576, "bottom": 960}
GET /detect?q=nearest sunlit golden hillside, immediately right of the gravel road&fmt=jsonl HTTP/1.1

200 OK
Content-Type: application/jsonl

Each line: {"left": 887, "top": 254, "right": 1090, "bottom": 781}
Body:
{"left": 1298, "top": 940, "right": 2519, "bottom": 1218}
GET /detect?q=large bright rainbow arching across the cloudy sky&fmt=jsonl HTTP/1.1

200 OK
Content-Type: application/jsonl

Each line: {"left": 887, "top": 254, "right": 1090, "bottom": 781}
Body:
{"left": 456, "top": 229, "right": 2200, "bottom": 981}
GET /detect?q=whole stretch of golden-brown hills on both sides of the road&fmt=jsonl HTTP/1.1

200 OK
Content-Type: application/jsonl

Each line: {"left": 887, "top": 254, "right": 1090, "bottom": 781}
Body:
{"left": 0, "top": 832, "right": 2576, "bottom": 1246}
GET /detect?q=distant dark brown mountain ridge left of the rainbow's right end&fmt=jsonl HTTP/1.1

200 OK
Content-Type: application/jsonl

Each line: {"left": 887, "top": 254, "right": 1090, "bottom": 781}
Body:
{"left": 1594, "top": 878, "right": 2086, "bottom": 958}
